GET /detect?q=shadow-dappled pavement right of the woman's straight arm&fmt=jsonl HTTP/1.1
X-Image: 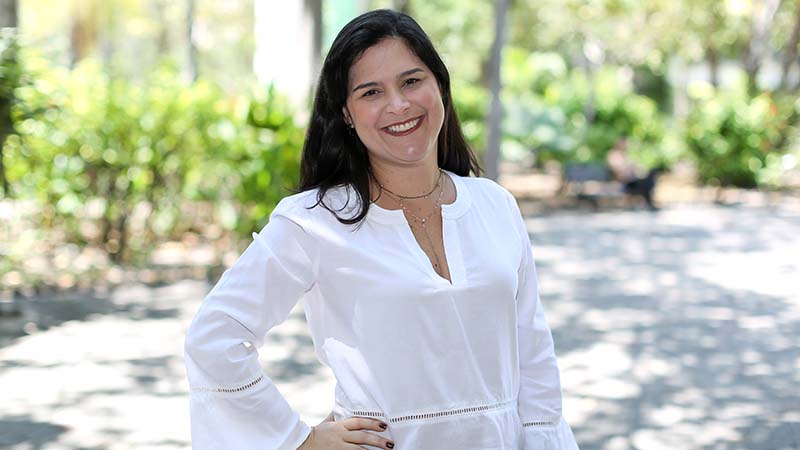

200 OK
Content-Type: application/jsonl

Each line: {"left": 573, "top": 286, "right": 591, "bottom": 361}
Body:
{"left": 528, "top": 207, "right": 800, "bottom": 450}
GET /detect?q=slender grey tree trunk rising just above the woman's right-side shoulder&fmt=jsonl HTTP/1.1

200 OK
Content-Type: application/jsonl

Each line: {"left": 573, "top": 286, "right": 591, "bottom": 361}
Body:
{"left": 484, "top": 0, "right": 508, "bottom": 180}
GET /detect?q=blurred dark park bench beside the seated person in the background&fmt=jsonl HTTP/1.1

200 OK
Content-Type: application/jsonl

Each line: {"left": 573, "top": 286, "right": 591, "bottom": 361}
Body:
{"left": 558, "top": 163, "right": 628, "bottom": 209}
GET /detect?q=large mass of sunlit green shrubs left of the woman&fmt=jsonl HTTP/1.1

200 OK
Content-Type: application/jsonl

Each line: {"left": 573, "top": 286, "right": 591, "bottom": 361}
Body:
{"left": 6, "top": 50, "right": 303, "bottom": 260}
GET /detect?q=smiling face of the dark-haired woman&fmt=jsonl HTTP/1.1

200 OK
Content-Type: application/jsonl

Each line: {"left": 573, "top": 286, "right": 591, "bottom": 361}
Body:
{"left": 343, "top": 38, "right": 444, "bottom": 170}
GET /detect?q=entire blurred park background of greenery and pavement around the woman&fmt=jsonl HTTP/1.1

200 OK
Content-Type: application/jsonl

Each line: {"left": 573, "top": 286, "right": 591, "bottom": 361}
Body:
{"left": 0, "top": 0, "right": 800, "bottom": 450}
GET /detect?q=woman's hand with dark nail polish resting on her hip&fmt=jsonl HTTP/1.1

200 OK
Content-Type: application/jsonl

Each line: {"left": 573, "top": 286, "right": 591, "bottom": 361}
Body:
{"left": 297, "top": 417, "right": 394, "bottom": 450}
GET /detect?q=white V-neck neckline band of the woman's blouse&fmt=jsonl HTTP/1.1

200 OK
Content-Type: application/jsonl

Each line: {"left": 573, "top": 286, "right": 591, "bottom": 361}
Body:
{"left": 367, "top": 170, "right": 471, "bottom": 287}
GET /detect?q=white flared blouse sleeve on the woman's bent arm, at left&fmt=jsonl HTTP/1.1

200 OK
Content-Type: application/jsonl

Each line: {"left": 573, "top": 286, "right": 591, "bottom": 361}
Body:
{"left": 185, "top": 201, "right": 317, "bottom": 450}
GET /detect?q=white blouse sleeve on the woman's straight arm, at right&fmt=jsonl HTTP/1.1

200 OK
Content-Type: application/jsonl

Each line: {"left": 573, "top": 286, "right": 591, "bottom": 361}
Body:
{"left": 509, "top": 195, "right": 578, "bottom": 450}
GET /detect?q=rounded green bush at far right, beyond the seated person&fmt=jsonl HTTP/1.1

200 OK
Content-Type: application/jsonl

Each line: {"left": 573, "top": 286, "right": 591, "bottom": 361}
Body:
{"left": 686, "top": 91, "right": 800, "bottom": 188}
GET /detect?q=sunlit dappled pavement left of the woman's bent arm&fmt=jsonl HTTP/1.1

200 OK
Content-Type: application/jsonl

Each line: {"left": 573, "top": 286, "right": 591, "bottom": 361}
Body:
{"left": 0, "top": 282, "right": 203, "bottom": 449}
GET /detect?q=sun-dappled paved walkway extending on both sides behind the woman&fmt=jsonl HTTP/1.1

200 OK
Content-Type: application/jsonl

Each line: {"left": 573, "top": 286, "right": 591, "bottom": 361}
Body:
{"left": 0, "top": 206, "right": 800, "bottom": 450}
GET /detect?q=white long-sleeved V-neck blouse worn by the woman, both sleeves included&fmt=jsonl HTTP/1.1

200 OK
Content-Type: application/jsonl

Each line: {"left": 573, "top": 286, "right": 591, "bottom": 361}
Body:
{"left": 185, "top": 172, "right": 578, "bottom": 450}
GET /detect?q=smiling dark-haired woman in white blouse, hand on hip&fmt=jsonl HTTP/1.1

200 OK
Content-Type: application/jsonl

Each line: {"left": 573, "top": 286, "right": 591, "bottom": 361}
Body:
{"left": 186, "top": 10, "right": 577, "bottom": 450}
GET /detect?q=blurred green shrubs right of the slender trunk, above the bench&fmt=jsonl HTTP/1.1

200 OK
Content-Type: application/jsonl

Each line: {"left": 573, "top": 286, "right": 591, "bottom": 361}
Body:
{"left": 504, "top": 48, "right": 673, "bottom": 166}
